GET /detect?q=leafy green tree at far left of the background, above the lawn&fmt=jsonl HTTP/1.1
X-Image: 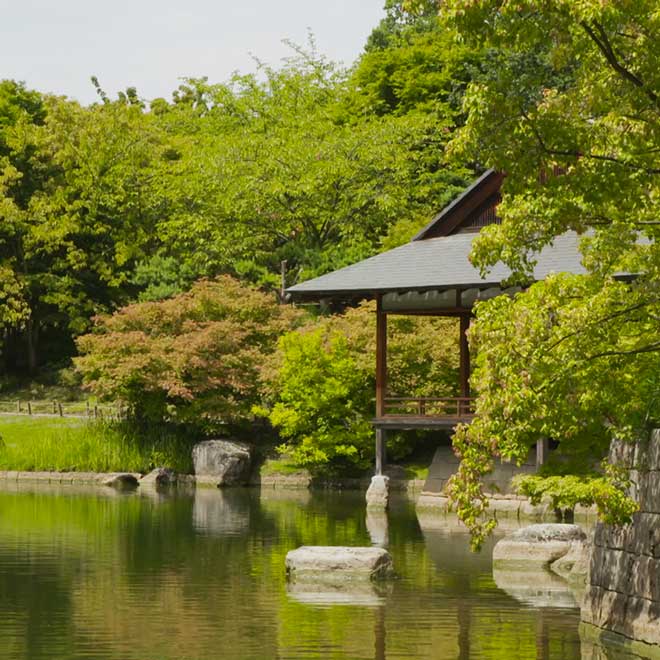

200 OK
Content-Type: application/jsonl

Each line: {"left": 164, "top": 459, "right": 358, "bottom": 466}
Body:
{"left": 0, "top": 83, "right": 178, "bottom": 373}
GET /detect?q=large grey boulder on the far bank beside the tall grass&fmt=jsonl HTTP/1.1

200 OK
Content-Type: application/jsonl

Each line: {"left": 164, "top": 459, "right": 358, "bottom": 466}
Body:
{"left": 193, "top": 440, "right": 252, "bottom": 486}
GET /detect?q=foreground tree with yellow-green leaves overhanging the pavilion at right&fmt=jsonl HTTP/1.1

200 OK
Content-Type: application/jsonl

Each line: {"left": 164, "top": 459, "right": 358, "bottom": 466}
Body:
{"left": 428, "top": 0, "right": 660, "bottom": 541}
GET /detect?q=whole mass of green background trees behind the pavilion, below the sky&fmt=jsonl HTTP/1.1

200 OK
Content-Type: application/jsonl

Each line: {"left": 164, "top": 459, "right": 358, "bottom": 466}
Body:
{"left": 0, "top": 23, "right": 474, "bottom": 374}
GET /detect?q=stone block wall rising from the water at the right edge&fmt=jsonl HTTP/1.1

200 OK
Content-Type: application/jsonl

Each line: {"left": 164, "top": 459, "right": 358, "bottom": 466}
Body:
{"left": 582, "top": 429, "right": 660, "bottom": 658}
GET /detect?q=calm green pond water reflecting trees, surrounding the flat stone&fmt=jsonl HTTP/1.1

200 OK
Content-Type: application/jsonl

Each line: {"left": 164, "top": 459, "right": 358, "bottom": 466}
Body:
{"left": 0, "top": 485, "right": 624, "bottom": 660}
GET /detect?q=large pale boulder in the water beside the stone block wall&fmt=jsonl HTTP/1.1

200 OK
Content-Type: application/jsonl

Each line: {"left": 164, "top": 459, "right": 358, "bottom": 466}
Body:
{"left": 493, "top": 523, "right": 587, "bottom": 570}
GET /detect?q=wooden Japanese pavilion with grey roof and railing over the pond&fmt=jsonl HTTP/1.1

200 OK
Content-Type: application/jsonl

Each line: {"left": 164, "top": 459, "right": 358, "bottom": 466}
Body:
{"left": 287, "top": 170, "right": 586, "bottom": 473}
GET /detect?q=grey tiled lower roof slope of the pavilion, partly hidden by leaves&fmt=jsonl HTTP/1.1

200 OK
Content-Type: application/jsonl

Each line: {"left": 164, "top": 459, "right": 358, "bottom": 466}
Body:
{"left": 287, "top": 232, "right": 586, "bottom": 299}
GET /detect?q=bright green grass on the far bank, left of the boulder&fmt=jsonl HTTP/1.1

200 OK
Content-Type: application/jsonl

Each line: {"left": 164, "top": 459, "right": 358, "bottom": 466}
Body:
{"left": 0, "top": 415, "right": 192, "bottom": 473}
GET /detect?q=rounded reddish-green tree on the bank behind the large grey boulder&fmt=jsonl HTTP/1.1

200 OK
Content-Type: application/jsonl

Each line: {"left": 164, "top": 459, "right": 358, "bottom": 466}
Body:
{"left": 75, "top": 276, "right": 299, "bottom": 429}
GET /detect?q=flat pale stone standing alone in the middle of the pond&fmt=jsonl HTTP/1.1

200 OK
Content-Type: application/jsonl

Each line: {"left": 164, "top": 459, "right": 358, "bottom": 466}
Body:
{"left": 286, "top": 545, "right": 394, "bottom": 581}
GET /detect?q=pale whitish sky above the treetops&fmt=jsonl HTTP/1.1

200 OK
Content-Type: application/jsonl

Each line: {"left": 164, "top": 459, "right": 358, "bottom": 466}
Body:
{"left": 0, "top": 0, "right": 384, "bottom": 103}
